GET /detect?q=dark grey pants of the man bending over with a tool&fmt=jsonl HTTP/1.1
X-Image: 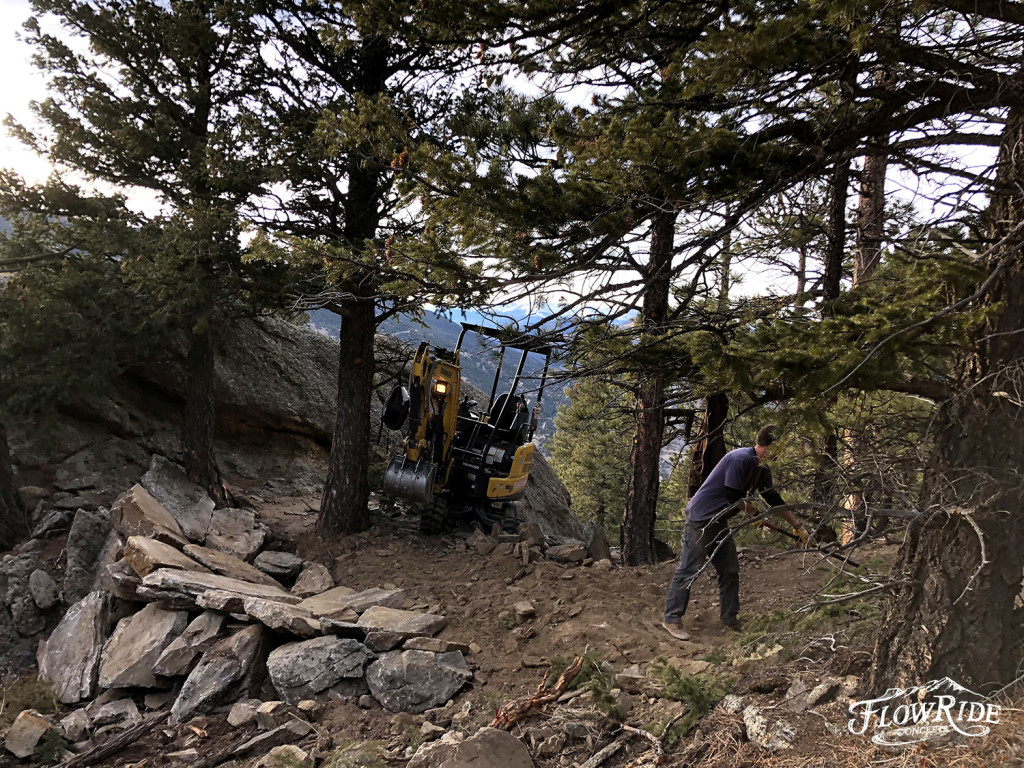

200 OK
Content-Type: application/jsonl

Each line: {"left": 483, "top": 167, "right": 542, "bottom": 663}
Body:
{"left": 665, "top": 518, "right": 739, "bottom": 624}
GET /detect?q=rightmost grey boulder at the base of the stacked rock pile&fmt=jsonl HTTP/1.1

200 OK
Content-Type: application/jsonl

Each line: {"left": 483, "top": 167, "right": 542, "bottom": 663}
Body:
{"left": 367, "top": 650, "right": 473, "bottom": 714}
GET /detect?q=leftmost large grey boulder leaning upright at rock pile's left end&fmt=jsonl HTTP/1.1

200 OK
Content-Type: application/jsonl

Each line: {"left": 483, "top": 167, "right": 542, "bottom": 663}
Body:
{"left": 39, "top": 592, "right": 111, "bottom": 703}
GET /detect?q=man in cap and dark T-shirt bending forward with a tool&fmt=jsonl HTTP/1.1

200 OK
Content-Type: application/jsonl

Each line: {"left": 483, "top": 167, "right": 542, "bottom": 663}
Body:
{"left": 662, "top": 425, "right": 808, "bottom": 640}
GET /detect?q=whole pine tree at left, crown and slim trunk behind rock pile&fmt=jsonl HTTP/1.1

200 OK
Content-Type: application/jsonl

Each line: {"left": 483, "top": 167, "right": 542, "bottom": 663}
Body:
{"left": 17, "top": 0, "right": 290, "bottom": 504}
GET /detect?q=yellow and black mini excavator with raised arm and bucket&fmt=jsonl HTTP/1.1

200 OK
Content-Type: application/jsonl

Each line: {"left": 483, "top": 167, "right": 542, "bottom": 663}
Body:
{"left": 382, "top": 323, "right": 552, "bottom": 534}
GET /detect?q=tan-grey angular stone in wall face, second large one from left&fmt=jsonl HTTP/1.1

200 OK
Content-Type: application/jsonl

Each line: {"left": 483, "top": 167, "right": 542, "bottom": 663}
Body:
{"left": 99, "top": 603, "right": 188, "bottom": 688}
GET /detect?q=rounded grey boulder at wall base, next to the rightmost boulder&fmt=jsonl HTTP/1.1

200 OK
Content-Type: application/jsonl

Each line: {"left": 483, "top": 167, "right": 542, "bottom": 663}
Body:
{"left": 266, "top": 637, "right": 374, "bottom": 705}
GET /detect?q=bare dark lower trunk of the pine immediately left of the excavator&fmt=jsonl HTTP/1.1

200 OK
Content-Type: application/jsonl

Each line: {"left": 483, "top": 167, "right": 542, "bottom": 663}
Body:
{"left": 317, "top": 300, "right": 377, "bottom": 534}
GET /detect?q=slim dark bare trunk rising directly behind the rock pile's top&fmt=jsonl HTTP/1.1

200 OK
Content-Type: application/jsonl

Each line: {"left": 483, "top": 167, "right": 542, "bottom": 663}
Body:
{"left": 181, "top": 323, "right": 228, "bottom": 507}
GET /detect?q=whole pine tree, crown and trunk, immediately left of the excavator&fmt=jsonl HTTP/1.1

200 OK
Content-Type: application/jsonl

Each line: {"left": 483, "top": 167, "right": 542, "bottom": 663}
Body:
{"left": 253, "top": 0, "right": 485, "bottom": 532}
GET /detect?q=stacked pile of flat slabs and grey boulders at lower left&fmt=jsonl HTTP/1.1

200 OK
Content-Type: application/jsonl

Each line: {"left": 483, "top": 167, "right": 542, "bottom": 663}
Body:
{"left": 8, "top": 459, "right": 473, "bottom": 765}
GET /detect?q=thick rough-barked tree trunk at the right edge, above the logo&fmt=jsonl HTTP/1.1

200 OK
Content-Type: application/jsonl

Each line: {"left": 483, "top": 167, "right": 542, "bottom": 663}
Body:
{"left": 871, "top": 100, "right": 1024, "bottom": 691}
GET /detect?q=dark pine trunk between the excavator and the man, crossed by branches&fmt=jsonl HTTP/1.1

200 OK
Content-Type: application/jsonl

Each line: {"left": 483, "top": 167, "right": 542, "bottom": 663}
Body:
{"left": 622, "top": 209, "right": 676, "bottom": 565}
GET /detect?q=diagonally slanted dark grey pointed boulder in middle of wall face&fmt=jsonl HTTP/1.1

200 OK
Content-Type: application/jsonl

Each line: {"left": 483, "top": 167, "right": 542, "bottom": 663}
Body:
{"left": 170, "top": 625, "right": 267, "bottom": 725}
